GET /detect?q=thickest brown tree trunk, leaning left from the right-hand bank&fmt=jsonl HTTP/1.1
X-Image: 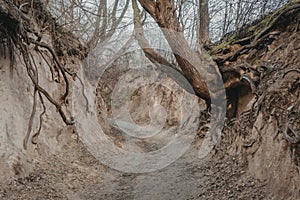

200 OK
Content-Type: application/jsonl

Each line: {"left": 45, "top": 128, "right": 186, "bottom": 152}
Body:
{"left": 139, "top": 0, "right": 225, "bottom": 101}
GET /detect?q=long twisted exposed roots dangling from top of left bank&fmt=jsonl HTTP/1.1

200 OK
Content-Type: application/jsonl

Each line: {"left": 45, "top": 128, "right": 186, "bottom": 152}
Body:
{"left": 0, "top": 0, "right": 88, "bottom": 149}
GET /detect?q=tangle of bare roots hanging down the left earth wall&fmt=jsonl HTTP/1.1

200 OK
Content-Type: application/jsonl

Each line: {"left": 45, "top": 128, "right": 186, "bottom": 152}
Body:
{"left": 0, "top": 0, "right": 85, "bottom": 149}
